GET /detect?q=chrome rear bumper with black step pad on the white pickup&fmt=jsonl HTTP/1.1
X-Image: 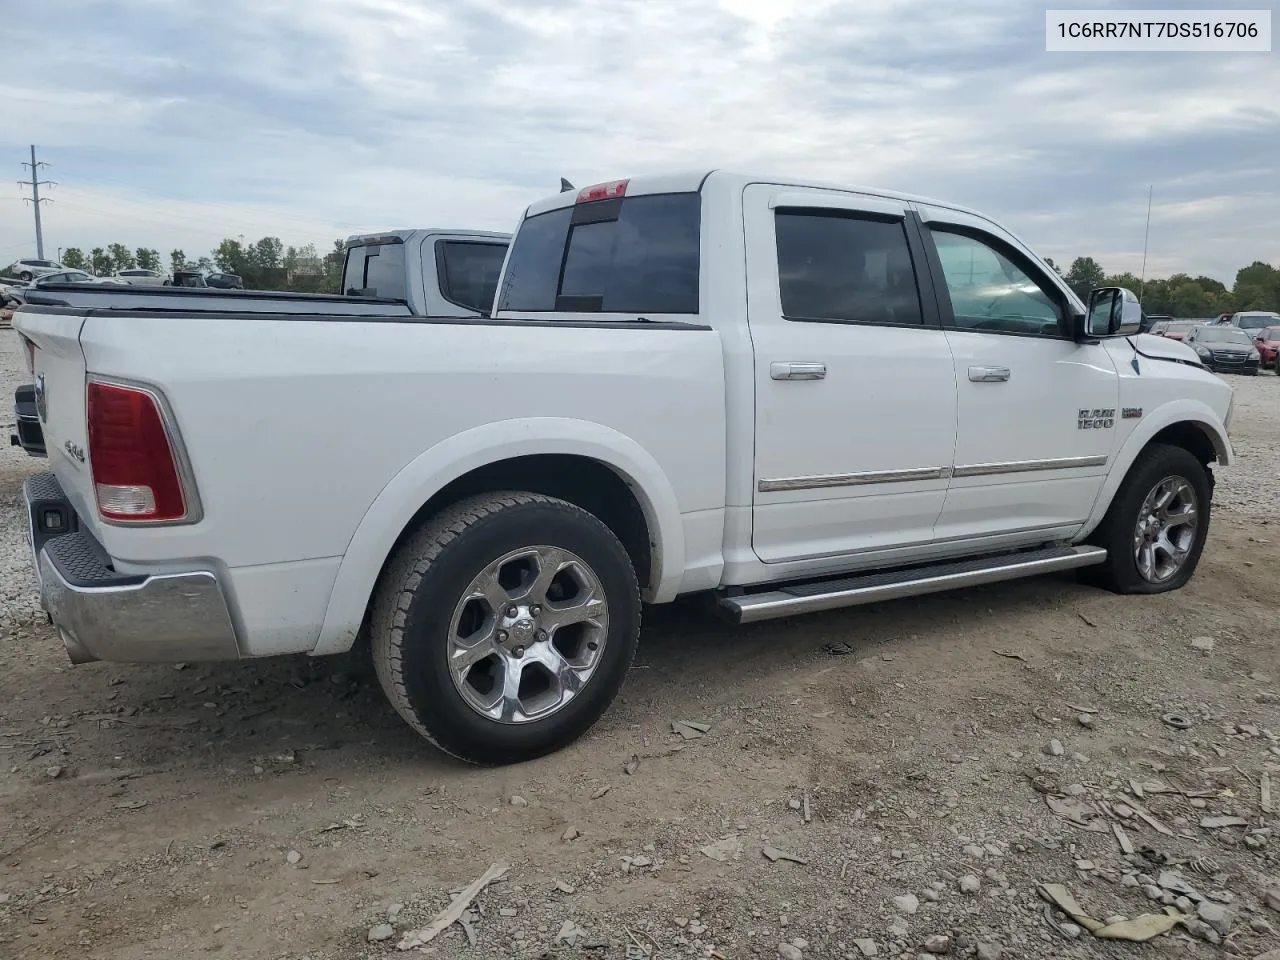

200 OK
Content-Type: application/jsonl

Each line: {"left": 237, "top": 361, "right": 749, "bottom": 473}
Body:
{"left": 23, "top": 474, "right": 239, "bottom": 663}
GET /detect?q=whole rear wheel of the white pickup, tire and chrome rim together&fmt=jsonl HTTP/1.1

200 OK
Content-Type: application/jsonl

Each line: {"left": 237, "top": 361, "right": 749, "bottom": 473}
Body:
{"left": 370, "top": 493, "right": 640, "bottom": 764}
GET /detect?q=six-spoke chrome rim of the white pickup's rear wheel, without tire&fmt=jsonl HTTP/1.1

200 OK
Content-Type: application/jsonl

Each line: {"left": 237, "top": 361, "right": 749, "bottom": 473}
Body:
{"left": 448, "top": 547, "right": 609, "bottom": 723}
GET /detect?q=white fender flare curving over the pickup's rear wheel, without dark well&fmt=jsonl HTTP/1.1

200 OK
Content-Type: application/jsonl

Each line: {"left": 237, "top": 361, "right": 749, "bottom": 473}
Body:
{"left": 312, "top": 417, "right": 685, "bottom": 655}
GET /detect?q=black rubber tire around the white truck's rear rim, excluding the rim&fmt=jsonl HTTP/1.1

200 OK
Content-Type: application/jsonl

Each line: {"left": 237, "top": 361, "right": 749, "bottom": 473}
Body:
{"left": 370, "top": 493, "right": 640, "bottom": 764}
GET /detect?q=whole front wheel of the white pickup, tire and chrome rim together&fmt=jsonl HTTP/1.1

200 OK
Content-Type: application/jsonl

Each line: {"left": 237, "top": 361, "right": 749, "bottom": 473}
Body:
{"left": 1085, "top": 444, "right": 1212, "bottom": 594}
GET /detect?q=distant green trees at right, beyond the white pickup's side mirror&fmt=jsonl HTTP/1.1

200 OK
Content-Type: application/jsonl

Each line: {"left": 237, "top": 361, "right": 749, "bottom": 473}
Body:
{"left": 1048, "top": 257, "right": 1280, "bottom": 317}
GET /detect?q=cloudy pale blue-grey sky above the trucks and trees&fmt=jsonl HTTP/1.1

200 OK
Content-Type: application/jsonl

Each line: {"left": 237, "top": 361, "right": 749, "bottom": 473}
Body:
{"left": 0, "top": 0, "right": 1280, "bottom": 283}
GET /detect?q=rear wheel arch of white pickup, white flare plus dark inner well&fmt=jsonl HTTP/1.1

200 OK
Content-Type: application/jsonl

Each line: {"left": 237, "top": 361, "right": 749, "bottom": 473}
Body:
{"left": 312, "top": 417, "right": 685, "bottom": 655}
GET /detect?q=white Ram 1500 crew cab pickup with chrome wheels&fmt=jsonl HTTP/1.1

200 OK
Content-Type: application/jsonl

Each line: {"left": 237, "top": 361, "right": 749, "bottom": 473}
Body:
{"left": 15, "top": 172, "right": 1231, "bottom": 763}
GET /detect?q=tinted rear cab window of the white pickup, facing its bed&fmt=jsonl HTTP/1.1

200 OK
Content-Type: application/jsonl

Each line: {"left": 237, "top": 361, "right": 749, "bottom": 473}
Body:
{"left": 498, "top": 192, "right": 701, "bottom": 317}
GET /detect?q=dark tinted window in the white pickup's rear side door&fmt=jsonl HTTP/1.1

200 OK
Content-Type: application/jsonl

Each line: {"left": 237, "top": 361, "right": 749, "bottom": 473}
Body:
{"left": 776, "top": 210, "right": 924, "bottom": 326}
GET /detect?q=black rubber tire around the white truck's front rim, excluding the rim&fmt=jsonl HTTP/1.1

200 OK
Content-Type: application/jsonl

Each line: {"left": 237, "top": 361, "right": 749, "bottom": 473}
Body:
{"left": 1082, "top": 443, "right": 1212, "bottom": 594}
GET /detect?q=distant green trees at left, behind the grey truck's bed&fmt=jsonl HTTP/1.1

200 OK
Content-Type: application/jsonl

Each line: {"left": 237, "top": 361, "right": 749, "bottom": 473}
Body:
{"left": 61, "top": 237, "right": 346, "bottom": 293}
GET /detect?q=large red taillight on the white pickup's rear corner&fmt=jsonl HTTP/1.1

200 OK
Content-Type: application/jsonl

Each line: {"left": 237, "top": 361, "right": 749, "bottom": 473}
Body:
{"left": 88, "top": 380, "right": 187, "bottom": 522}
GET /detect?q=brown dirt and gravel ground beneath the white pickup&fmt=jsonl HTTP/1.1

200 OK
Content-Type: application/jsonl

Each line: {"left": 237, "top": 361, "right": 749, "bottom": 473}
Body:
{"left": 0, "top": 332, "right": 1280, "bottom": 960}
